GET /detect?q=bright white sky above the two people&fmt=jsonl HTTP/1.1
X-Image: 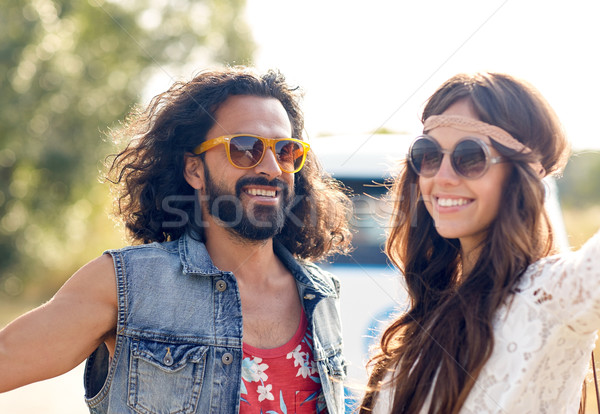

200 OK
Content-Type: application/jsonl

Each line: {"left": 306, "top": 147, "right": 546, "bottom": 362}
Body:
{"left": 247, "top": 0, "right": 600, "bottom": 149}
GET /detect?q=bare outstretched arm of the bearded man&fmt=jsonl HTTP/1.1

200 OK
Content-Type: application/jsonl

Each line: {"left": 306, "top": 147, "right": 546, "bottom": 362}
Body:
{"left": 0, "top": 255, "right": 117, "bottom": 392}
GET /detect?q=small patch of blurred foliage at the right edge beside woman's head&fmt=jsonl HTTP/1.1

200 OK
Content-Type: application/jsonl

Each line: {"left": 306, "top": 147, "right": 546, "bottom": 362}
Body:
{"left": 557, "top": 151, "right": 600, "bottom": 209}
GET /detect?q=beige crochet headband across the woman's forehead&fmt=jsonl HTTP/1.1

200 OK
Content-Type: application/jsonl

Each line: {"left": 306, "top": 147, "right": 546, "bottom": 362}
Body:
{"left": 423, "top": 115, "right": 546, "bottom": 177}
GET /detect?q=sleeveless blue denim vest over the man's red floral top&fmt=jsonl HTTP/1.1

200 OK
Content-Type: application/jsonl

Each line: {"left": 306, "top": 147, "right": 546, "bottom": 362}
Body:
{"left": 84, "top": 234, "right": 346, "bottom": 414}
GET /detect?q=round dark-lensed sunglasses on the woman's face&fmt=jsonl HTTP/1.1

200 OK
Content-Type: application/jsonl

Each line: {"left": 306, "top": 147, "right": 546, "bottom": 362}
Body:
{"left": 408, "top": 135, "right": 504, "bottom": 180}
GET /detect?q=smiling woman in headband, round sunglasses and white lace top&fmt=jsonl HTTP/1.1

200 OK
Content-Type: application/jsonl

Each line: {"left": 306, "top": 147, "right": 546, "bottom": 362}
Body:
{"left": 361, "top": 73, "right": 600, "bottom": 414}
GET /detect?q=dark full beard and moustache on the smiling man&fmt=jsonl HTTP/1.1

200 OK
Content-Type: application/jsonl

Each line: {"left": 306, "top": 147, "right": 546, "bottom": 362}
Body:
{"left": 204, "top": 165, "right": 294, "bottom": 241}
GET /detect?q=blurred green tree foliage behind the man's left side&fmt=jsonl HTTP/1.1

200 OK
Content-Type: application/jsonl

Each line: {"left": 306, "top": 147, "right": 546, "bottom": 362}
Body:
{"left": 0, "top": 0, "right": 253, "bottom": 299}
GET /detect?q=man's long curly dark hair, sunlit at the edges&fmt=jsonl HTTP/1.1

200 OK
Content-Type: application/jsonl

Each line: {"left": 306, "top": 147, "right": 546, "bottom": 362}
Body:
{"left": 108, "top": 67, "right": 351, "bottom": 260}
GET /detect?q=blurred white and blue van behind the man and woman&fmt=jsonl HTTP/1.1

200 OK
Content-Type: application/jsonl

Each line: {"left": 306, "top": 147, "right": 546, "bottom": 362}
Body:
{"left": 310, "top": 134, "right": 568, "bottom": 413}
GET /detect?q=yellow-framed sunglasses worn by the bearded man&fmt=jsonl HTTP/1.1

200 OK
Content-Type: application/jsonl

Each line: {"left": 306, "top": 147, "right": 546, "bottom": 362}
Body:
{"left": 194, "top": 134, "right": 310, "bottom": 173}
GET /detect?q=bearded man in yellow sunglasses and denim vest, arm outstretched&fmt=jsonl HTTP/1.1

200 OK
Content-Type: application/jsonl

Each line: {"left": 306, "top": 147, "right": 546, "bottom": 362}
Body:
{"left": 0, "top": 68, "right": 350, "bottom": 414}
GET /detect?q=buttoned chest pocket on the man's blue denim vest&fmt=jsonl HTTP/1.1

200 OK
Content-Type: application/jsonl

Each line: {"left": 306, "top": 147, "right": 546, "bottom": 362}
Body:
{"left": 127, "top": 340, "right": 208, "bottom": 414}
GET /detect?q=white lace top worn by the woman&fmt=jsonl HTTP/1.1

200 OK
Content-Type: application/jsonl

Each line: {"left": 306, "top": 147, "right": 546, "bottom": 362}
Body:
{"left": 373, "top": 233, "right": 600, "bottom": 414}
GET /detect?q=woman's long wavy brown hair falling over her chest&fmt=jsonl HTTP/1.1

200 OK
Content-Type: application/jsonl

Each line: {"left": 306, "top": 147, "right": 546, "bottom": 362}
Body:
{"left": 360, "top": 73, "right": 568, "bottom": 414}
